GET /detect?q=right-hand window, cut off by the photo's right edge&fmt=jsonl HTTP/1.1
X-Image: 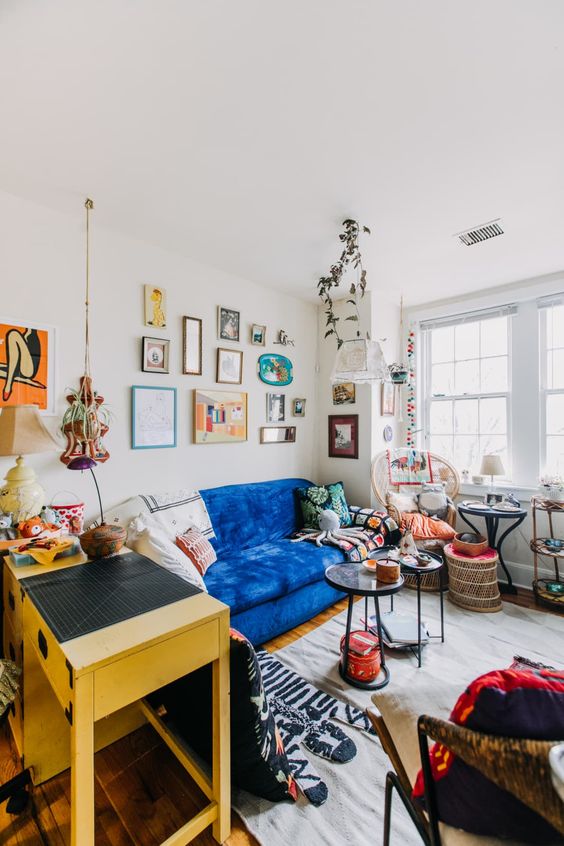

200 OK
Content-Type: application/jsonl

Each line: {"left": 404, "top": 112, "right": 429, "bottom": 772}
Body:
{"left": 539, "top": 301, "right": 564, "bottom": 476}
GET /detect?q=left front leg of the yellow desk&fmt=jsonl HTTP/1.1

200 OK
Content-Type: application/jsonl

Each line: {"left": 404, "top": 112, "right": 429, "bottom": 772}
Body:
{"left": 71, "top": 673, "right": 94, "bottom": 846}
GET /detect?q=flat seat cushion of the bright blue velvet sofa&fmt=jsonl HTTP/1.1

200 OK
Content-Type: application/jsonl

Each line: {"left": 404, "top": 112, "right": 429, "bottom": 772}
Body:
{"left": 204, "top": 544, "right": 344, "bottom": 616}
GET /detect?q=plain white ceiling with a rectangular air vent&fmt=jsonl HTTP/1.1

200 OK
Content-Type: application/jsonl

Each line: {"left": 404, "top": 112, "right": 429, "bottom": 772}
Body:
{"left": 0, "top": 0, "right": 564, "bottom": 304}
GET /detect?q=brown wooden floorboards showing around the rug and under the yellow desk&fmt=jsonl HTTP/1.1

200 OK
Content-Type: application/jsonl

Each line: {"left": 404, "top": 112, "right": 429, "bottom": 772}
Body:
{"left": 0, "top": 591, "right": 556, "bottom": 846}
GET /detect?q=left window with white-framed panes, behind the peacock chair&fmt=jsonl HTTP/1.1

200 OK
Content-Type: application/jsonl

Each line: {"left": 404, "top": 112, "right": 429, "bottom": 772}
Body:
{"left": 421, "top": 314, "right": 512, "bottom": 476}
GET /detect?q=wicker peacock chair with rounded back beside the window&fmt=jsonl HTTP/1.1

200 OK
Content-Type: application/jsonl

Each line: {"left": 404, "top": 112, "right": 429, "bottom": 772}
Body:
{"left": 371, "top": 450, "right": 460, "bottom": 591}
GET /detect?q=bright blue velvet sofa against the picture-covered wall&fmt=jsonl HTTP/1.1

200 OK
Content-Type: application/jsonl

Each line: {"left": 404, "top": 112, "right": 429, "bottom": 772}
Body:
{"left": 200, "top": 479, "right": 364, "bottom": 645}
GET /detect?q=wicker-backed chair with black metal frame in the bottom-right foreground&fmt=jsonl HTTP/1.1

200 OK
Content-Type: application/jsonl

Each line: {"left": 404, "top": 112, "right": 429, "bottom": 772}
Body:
{"left": 368, "top": 710, "right": 564, "bottom": 846}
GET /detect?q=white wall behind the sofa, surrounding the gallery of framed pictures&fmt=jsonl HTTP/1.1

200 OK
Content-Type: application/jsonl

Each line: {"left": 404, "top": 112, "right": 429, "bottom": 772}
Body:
{"left": 0, "top": 193, "right": 317, "bottom": 514}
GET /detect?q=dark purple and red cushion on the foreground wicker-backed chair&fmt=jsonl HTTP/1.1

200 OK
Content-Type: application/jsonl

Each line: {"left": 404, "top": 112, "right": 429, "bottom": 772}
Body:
{"left": 413, "top": 669, "right": 564, "bottom": 843}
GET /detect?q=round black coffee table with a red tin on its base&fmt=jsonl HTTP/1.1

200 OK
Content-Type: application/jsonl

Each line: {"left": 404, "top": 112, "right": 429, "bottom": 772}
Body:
{"left": 325, "top": 562, "right": 404, "bottom": 690}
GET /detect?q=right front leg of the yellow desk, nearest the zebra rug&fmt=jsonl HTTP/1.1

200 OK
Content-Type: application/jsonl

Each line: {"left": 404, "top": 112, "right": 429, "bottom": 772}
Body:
{"left": 212, "top": 614, "right": 231, "bottom": 843}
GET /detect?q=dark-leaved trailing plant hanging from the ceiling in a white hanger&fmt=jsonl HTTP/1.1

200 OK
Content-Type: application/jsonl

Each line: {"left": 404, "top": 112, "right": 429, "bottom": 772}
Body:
{"left": 317, "top": 218, "right": 370, "bottom": 348}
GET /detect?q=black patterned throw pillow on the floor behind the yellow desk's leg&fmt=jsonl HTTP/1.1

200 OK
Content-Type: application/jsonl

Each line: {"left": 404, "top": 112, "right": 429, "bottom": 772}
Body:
{"left": 150, "top": 629, "right": 297, "bottom": 802}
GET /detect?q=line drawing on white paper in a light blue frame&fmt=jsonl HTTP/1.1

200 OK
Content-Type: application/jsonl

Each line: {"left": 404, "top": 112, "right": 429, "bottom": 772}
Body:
{"left": 131, "top": 385, "right": 176, "bottom": 449}
